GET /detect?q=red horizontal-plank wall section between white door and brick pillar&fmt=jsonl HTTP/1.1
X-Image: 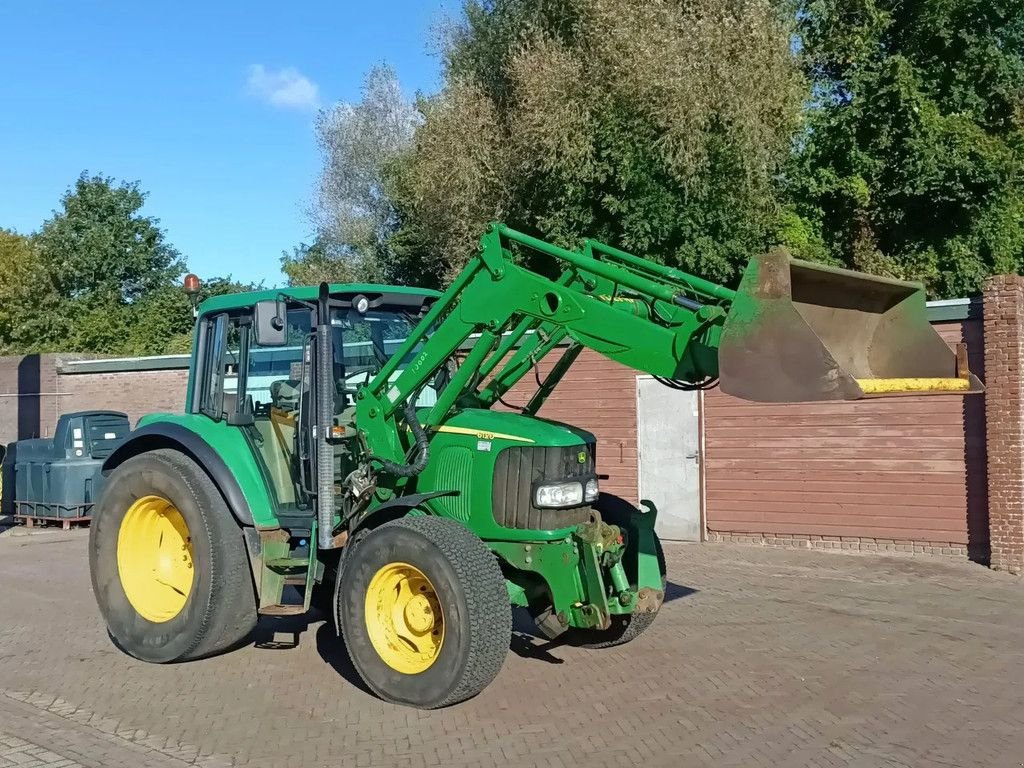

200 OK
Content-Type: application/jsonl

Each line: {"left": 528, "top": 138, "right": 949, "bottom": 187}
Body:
{"left": 705, "top": 321, "right": 987, "bottom": 557}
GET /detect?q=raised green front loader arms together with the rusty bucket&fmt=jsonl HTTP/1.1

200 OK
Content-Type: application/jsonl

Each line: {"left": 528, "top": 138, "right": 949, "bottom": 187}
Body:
{"left": 357, "top": 219, "right": 981, "bottom": 461}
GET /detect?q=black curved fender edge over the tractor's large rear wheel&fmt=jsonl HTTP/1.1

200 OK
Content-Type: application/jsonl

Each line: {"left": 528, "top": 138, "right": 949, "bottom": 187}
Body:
{"left": 101, "top": 422, "right": 253, "bottom": 525}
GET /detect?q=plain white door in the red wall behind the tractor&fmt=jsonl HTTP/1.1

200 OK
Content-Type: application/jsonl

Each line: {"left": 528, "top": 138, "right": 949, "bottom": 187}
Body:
{"left": 637, "top": 377, "right": 700, "bottom": 542}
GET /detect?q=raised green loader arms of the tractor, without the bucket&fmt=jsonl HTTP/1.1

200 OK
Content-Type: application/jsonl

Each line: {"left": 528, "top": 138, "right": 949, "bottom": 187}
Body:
{"left": 357, "top": 224, "right": 726, "bottom": 461}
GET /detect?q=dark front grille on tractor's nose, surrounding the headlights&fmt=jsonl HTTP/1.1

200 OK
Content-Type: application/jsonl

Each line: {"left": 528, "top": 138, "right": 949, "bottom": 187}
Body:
{"left": 492, "top": 442, "right": 596, "bottom": 530}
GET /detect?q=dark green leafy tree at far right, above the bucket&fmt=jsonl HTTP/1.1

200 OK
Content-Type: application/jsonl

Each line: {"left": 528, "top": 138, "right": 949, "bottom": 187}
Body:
{"left": 787, "top": 0, "right": 1024, "bottom": 297}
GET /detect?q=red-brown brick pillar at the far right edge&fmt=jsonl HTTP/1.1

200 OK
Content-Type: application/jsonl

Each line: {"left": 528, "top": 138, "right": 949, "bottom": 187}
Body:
{"left": 984, "top": 275, "right": 1024, "bottom": 573}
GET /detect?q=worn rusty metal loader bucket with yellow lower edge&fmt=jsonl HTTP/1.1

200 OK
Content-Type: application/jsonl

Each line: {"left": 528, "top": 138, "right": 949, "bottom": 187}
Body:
{"left": 719, "top": 251, "right": 982, "bottom": 402}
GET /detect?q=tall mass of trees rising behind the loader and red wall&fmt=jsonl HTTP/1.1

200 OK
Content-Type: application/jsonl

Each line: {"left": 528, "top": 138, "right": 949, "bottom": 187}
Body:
{"left": 299, "top": 0, "right": 1024, "bottom": 297}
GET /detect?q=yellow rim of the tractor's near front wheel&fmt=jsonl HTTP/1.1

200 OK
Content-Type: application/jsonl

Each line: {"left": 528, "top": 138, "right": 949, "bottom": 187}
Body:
{"left": 366, "top": 562, "right": 444, "bottom": 675}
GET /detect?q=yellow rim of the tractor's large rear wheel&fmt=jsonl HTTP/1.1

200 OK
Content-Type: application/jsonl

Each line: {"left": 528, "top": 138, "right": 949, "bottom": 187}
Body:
{"left": 118, "top": 496, "right": 195, "bottom": 624}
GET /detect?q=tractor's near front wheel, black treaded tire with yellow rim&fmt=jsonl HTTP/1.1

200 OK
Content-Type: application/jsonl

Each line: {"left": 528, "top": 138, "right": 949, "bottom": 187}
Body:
{"left": 338, "top": 517, "right": 512, "bottom": 709}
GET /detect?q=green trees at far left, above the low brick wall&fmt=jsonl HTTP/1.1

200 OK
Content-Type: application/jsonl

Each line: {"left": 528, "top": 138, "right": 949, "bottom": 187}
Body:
{"left": 0, "top": 174, "right": 253, "bottom": 355}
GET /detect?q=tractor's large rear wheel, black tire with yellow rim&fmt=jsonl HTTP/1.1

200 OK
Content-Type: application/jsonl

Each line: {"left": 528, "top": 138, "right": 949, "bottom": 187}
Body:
{"left": 89, "top": 450, "right": 256, "bottom": 663}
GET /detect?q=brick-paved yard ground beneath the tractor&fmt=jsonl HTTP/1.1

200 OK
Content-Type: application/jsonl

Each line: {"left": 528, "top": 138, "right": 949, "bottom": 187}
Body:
{"left": 0, "top": 531, "right": 1024, "bottom": 768}
